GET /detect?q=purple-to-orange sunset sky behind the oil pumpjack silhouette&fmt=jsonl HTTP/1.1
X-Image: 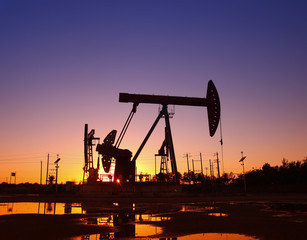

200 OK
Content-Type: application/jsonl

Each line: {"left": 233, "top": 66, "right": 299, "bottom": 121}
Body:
{"left": 0, "top": 0, "right": 307, "bottom": 183}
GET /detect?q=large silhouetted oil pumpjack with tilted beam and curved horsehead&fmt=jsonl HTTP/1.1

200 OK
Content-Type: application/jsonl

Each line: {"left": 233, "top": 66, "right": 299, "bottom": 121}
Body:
{"left": 84, "top": 80, "right": 221, "bottom": 183}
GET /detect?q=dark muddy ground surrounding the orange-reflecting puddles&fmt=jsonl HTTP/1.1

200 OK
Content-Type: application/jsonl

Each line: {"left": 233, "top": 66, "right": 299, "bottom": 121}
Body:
{"left": 0, "top": 194, "right": 307, "bottom": 240}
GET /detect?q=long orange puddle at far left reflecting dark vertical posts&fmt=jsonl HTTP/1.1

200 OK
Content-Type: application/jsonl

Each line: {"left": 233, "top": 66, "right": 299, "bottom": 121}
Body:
{"left": 0, "top": 202, "right": 83, "bottom": 215}
